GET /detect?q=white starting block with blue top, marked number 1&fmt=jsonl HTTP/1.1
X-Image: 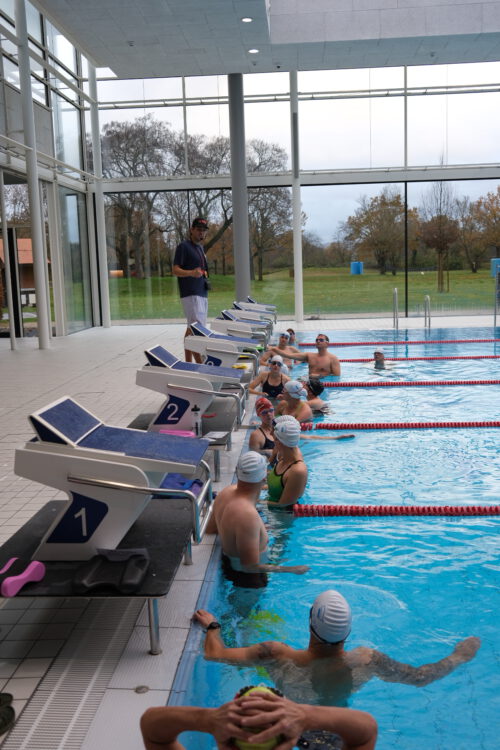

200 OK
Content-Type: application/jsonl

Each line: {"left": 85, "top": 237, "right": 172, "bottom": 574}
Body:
{"left": 15, "top": 396, "right": 212, "bottom": 560}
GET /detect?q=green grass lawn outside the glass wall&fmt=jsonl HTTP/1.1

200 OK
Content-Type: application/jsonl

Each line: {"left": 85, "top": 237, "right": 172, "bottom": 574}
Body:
{"left": 110, "top": 268, "right": 494, "bottom": 320}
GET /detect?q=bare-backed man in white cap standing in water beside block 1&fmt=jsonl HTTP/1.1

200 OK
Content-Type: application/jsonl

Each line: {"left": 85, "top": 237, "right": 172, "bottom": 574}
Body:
{"left": 207, "top": 451, "right": 309, "bottom": 588}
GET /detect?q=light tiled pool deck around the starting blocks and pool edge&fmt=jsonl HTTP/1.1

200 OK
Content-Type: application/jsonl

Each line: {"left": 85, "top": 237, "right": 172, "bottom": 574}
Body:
{"left": 0, "top": 316, "right": 493, "bottom": 750}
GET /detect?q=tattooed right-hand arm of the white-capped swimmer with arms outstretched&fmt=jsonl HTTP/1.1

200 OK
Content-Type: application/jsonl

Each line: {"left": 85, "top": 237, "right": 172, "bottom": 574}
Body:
{"left": 368, "top": 636, "right": 481, "bottom": 687}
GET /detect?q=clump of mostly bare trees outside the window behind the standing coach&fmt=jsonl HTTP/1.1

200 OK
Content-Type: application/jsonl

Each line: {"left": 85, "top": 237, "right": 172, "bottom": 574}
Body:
{"left": 102, "top": 115, "right": 291, "bottom": 279}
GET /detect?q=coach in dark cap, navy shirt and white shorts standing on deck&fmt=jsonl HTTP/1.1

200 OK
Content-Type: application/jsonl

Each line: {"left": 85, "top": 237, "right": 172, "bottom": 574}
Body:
{"left": 172, "top": 216, "right": 210, "bottom": 362}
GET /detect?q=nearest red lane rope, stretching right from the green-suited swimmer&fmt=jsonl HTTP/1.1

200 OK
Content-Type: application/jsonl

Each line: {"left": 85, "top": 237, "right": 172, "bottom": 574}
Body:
{"left": 293, "top": 505, "right": 500, "bottom": 517}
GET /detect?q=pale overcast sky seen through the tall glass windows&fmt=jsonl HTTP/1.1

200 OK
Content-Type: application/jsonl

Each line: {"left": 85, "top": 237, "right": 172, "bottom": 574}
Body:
{"left": 99, "top": 63, "right": 500, "bottom": 242}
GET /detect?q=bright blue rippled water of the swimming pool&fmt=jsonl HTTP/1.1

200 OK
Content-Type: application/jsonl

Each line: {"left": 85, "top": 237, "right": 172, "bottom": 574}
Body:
{"left": 174, "top": 329, "right": 500, "bottom": 750}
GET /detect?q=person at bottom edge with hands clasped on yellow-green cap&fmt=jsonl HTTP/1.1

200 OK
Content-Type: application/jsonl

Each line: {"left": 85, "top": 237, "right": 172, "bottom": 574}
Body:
{"left": 141, "top": 685, "right": 377, "bottom": 750}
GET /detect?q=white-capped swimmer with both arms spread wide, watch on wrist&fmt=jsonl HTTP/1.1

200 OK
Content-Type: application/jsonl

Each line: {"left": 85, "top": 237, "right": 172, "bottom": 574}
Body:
{"left": 194, "top": 589, "right": 481, "bottom": 705}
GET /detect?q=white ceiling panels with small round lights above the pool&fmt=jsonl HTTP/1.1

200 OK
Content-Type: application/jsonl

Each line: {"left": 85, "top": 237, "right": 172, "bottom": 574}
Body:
{"left": 34, "top": 0, "right": 500, "bottom": 78}
